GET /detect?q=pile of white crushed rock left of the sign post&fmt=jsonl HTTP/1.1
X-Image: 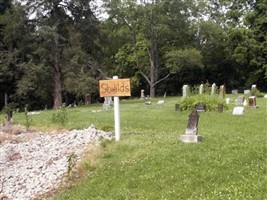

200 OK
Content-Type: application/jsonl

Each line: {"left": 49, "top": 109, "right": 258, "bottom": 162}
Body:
{"left": 0, "top": 125, "right": 114, "bottom": 200}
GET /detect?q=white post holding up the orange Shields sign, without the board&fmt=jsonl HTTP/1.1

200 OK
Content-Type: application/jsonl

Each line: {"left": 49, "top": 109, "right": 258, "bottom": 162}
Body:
{"left": 113, "top": 76, "right": 121, "bottom": 141}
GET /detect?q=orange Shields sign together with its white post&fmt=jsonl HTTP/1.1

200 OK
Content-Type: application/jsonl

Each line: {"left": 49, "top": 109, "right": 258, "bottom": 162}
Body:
{"left": 99, "top": 76, "right": 131, "bottom": 141}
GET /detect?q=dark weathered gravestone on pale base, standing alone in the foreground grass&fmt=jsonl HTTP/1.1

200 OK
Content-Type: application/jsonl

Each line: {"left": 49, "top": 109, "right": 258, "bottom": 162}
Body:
{"left": 180, "top": 109, "right": 202, "bottom": 143}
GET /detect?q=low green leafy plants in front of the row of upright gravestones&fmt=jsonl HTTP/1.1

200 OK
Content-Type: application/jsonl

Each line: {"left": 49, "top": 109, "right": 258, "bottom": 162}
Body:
{"left": 178, "top": 95, "right": 227, "bottom": 111}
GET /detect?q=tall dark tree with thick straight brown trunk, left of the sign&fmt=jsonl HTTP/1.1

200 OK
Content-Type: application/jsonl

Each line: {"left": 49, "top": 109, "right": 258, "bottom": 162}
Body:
{"left": 20, "top": 0, "right": 100, "bottom": 108}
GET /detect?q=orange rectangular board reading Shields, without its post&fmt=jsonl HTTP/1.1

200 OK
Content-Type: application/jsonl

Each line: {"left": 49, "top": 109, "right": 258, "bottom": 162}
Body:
{"left": 99, "top": 78, "right": 131, "bottom": 97}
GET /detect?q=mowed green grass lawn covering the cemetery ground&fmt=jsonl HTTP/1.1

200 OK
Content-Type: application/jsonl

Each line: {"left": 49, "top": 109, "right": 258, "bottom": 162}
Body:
{"left": 1, "top": 96, "right": 267, "bottom": 200}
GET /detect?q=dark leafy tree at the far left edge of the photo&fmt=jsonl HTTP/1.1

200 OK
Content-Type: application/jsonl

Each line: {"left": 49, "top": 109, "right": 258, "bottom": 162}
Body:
{"left": 0, "top": 1, "right": 31, "bottom": 109}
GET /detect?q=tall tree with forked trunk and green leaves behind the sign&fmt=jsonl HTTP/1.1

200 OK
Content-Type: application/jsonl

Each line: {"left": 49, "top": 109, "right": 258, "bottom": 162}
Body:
{"left": 103, "top": 0, "right": 198, "bottom": 97}
